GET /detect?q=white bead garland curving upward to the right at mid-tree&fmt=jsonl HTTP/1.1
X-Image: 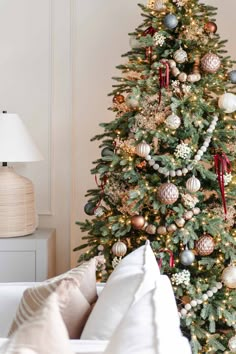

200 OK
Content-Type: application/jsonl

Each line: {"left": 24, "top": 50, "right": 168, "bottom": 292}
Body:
{"left": 145, "top": 116, "right": 219, "bottom": 177}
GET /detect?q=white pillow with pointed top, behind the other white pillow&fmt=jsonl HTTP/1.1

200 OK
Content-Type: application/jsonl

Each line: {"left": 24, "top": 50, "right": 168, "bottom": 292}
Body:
{"left": 81, "top": 241, "right": 160, "bottom": 340}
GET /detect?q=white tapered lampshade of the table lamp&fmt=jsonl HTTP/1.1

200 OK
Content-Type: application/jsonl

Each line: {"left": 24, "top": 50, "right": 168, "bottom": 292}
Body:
{"left": 0, "top": 113, "right": 43, "bottom": 162}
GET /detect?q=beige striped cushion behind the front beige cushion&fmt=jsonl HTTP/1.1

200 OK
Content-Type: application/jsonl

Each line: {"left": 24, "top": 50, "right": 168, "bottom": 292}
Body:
{"left": 9, "top": 259, "right": 97, "bottom": 338}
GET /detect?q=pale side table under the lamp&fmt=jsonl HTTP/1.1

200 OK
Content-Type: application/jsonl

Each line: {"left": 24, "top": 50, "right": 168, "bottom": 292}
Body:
{"left": 0, "top": 229, "right": 56, "bottom": 282}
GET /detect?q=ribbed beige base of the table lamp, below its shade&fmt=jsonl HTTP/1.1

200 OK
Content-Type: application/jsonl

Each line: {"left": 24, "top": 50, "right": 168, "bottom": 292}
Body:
{"left": 0, "top": 167, "right": 36, "bottom": 237}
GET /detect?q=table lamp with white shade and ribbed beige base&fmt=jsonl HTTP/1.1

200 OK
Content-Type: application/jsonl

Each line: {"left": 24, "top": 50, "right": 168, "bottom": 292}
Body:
{"left": 0, "top": 111, "right": 43, "bottom": 237}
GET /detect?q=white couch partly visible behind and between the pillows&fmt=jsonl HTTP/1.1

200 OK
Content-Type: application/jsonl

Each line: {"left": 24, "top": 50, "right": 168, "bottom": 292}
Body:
{"left": 0, "top": 283, "right": 107, "bottom": 354}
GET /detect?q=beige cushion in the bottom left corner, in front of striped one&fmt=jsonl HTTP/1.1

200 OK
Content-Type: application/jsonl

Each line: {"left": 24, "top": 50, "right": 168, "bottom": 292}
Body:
{"left": 0, "top": 292, "right": 73, "bottom": 354}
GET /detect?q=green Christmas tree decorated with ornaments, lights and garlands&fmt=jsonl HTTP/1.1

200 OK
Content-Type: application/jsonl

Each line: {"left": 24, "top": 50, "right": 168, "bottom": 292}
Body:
{"left": 75, "top": 0, "right": 236, "bottom": 354}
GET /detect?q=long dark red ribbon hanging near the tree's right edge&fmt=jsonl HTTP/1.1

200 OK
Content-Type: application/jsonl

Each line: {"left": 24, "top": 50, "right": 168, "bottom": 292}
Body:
{"left": 214, "top": 153, "right": 231, "bottom": 220}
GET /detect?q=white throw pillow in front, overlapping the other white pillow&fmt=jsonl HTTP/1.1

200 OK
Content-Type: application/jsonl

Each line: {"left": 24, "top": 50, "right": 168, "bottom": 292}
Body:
{"left": 104, "top": 276, "right": 191, "bottom": 354}
